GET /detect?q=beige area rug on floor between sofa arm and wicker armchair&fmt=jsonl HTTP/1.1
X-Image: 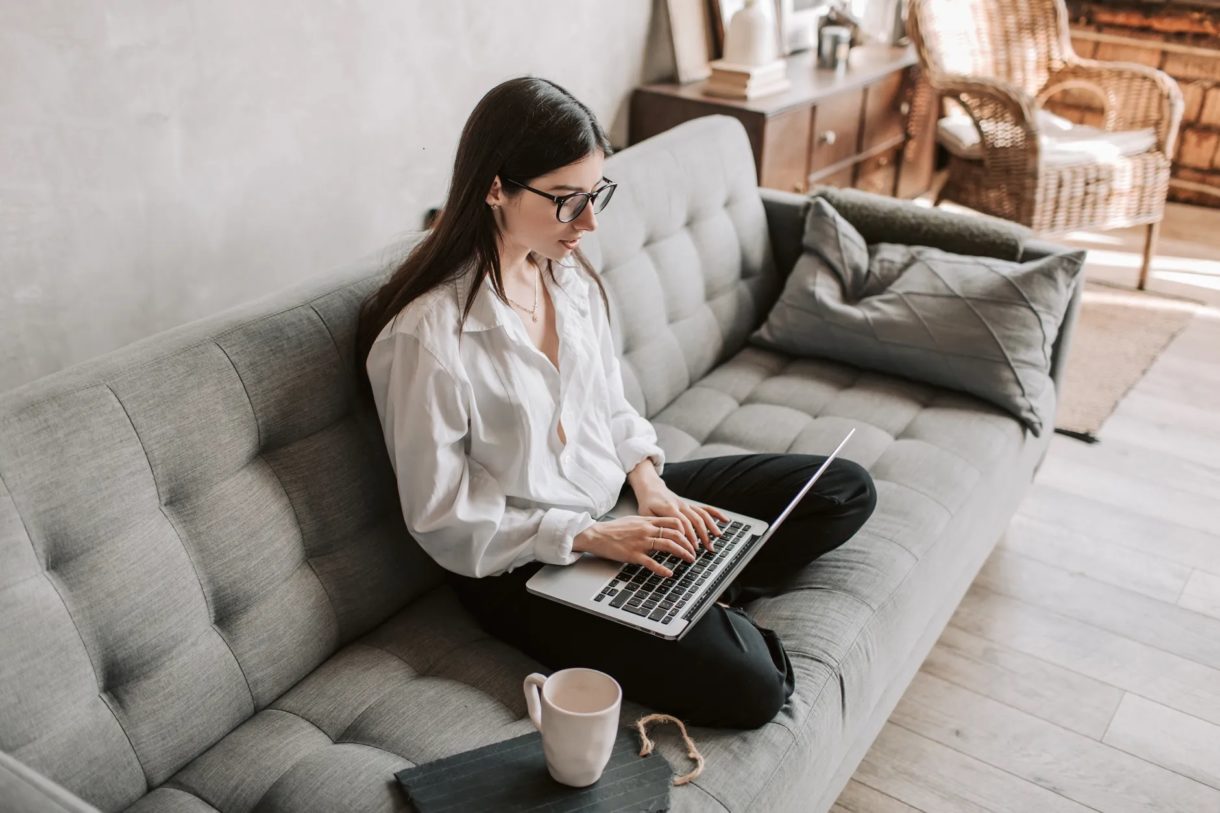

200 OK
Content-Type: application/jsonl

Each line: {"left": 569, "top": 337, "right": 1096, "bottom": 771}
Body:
{"left": 1055, "top": 282, "right": 1202, "bottom": 442}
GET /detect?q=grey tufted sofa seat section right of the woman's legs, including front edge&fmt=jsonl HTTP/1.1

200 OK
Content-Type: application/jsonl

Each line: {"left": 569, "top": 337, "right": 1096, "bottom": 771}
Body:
{"left": 653, "top": 345, "right": 1054, "bottom": 811}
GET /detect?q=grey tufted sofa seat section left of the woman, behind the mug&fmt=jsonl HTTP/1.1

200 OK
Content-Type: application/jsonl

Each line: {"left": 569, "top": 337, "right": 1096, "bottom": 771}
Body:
{"left": 128, "top": 585, "right": 683, "bottom": 813}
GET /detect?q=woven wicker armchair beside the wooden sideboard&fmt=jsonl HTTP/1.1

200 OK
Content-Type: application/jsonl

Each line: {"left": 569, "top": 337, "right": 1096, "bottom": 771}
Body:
{"left": 908, "top": 0, "right": 1182, "bottom": 288}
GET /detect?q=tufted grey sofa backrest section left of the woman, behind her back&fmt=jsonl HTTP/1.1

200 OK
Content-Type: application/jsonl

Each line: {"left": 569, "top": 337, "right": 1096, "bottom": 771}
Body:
{"left": 0, "top": 235, "right": 442, "bottom": 809}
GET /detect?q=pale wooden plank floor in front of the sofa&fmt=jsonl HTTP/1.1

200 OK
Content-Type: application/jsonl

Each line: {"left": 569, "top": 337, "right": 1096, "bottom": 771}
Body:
{"left": 833, "top": 205, "right": 1220, "bottom": 813}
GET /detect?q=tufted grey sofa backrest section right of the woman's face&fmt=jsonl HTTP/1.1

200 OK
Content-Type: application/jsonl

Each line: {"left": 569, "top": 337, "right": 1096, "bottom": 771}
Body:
{"left": 582, "top": 115, "right": 782, "bottom": 417}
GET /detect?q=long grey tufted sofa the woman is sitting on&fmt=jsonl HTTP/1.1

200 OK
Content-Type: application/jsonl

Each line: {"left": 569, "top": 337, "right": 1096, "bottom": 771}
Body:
{"left": 0, "top": 117, "right": 1075, "bottom": 812}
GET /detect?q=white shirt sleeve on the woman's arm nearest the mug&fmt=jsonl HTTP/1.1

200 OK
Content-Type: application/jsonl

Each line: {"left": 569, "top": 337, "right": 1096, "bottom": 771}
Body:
{"left": 367, "top": 332, "right": 594, "bottom": 577}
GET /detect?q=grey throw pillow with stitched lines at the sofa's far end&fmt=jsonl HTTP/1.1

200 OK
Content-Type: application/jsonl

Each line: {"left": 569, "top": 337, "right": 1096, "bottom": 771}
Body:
{"left": 750, "top": 199, "right": 1085, "bottom": 435}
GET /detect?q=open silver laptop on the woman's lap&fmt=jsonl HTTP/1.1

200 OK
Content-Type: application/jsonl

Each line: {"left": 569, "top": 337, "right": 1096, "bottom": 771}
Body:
{"left": 526, "top": 428, "right": 855, "bottom": 640}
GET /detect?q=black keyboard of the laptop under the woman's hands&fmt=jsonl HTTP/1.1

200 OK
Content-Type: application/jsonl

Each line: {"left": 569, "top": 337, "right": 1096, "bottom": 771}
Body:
{"left": 593, "top": 520, "right": 749, "bottom": 624}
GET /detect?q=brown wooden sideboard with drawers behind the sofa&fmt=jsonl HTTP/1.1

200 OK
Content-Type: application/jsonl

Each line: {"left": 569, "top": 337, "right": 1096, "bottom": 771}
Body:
{"left": 628, "top": 45, "right": 936, "bottom": 198}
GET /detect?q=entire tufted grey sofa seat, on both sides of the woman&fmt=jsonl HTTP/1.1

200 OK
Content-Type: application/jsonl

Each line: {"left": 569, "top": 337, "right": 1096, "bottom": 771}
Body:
{"left": 131, "top": 347, "right": 1042, "bottom": 812}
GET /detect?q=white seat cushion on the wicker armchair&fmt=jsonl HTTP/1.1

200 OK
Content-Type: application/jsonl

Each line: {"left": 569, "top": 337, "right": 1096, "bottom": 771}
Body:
{"left": 936, "top": 110, "right": 1157, "bottom": 166}
